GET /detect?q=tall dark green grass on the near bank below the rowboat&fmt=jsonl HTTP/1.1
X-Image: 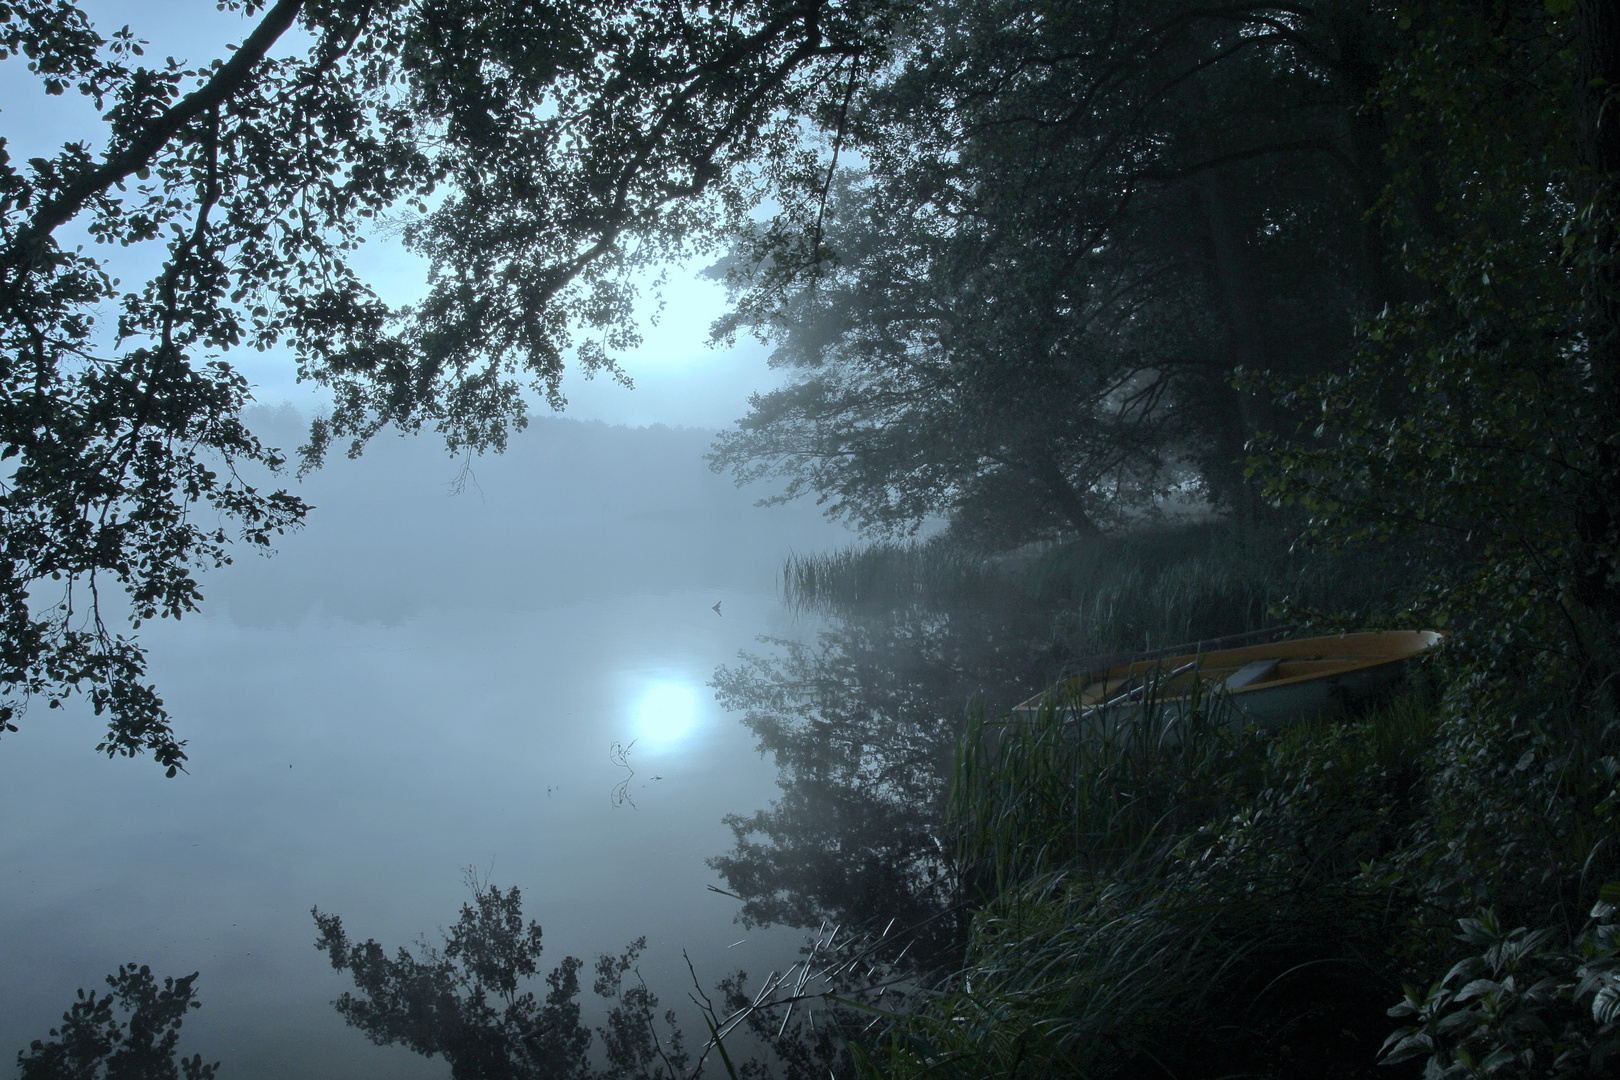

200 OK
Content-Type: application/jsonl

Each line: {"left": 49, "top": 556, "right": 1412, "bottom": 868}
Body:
{"left": 863, "top": 683, "right": 1432, "bottom": 1080}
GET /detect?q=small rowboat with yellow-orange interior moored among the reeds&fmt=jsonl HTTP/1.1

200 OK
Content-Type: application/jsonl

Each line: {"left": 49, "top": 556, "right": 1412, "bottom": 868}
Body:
{"left": 1013, "top": 630, "right": 1442, "bottom": 727}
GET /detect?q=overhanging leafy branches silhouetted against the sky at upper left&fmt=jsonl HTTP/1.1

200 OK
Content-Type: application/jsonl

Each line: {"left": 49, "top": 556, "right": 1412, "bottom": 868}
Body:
{"left": 0, "top": 0, "right": 894, "bottom": 774}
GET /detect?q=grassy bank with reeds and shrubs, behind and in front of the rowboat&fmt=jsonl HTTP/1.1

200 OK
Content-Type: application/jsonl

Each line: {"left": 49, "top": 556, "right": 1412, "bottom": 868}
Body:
{"left": 771, "top": 525, "right": 1620, "bottom": 1080}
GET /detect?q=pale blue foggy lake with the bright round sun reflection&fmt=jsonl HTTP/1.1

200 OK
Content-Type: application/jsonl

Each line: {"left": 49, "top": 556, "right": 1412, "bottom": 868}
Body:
{"left": 0, "top": 410, "right": 851, "bottom": 1078}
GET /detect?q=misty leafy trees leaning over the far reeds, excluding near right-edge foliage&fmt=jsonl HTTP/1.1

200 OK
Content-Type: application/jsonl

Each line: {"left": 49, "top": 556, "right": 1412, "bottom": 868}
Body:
{"left": 714, "top": 0, "right": 1398, "bottom": 542}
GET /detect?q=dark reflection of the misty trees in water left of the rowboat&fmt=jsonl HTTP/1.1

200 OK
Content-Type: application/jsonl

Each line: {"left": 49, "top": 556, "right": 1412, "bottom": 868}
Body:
{"left": 710, "top": 601, "right": 1050, "bottom": 968}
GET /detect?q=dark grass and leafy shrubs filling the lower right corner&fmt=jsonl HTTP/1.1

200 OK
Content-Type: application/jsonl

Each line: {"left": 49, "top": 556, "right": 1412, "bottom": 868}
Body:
{"left": 848, "top": 670, "right": 1620, "bottom": 1078}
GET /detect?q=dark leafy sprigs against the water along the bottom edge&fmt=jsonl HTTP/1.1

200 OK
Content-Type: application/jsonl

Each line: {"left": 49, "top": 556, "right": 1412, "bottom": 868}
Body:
{"left": 302, "top": 870, "right": 906, "bottom": 1080}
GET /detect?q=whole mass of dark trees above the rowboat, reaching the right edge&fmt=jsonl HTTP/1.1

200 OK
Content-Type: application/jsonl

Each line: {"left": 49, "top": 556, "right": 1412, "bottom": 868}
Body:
{"left": 713, "top": 0, "right": 1620, "bottom": 678}
